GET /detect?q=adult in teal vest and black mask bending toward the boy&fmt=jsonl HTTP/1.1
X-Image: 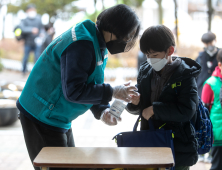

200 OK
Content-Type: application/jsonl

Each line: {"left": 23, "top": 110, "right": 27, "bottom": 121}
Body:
{"left": 17, "top": 4, "right": 140, "bottom": 170}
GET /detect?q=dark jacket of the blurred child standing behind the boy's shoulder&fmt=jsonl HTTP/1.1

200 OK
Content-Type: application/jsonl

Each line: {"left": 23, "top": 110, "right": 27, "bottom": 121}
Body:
{"left": 196, "top": 49, "right": 219, "bottom": 97}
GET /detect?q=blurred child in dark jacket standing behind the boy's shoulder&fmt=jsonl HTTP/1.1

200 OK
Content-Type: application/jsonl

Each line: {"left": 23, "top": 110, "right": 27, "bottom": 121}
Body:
{"left": 196, "top": 32, "right": 219, "bottom": 97}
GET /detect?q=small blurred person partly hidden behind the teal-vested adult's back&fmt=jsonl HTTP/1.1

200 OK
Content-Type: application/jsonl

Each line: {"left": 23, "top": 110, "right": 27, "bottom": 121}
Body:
{"left": 41, "top": 23, "right": 55, "bottom": 53}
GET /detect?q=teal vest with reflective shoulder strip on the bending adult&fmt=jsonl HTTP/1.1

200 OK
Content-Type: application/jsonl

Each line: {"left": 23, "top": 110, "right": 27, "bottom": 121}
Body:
{"left": 19, "top": 20, "right": 108, "bottom": 129}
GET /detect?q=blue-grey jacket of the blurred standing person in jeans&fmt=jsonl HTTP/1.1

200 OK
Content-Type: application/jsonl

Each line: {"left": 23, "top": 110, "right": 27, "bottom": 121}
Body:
{"left": 19, "top": 15, "right": 43, "bottom": 46}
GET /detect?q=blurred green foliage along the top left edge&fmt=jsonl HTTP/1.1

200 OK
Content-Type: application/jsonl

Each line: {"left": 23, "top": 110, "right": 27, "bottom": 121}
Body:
{"left": 8, "top": 0, "right": 81, "bottom": 19}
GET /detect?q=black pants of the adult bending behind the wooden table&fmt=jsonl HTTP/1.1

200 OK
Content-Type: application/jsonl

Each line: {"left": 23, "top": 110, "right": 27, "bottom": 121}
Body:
{"left": 20, "top": 113, "right": 75, "bottom": 170}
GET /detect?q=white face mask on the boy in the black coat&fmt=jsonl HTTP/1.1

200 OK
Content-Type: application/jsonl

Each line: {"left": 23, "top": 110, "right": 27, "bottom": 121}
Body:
{"left": 147, "top": 55, "right": 168, "bottom": 71}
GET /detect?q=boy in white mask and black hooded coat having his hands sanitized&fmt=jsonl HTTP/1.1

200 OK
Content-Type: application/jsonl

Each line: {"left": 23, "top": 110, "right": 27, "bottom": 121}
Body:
{"left": 126, "top": 25, "right": 201, "bottom": 170}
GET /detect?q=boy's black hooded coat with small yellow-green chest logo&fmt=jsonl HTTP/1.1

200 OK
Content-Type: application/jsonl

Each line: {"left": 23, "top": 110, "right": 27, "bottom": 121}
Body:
{"left": 126, "top": 58, "right": 201, "bottom": 166}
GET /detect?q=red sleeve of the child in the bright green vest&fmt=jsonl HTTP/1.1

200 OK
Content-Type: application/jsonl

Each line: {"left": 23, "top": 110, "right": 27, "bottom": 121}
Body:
{"left": 201, "top": 84, "right": 214, "bottom": 111}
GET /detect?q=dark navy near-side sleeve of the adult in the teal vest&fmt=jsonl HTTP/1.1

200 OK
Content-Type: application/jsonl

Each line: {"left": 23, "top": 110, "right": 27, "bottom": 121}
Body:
{"left": 60, "top": 40, "right": 113, "bottom": 105}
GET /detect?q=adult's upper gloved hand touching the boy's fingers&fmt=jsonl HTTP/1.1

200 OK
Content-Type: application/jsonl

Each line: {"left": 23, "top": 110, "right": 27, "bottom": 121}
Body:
{"left": 113, "top": 82, "right": 139, "bottom": 103}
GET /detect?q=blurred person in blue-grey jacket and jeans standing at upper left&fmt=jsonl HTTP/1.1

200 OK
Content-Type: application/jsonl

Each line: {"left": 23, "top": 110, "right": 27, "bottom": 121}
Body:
{"left": 19, "top": 4, "right": 43, "bottom": 75}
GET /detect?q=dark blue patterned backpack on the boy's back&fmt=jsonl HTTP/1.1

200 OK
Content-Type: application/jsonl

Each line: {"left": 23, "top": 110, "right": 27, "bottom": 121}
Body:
{"left": 172, "top": 84, "right": 213, "bottom": 155}
